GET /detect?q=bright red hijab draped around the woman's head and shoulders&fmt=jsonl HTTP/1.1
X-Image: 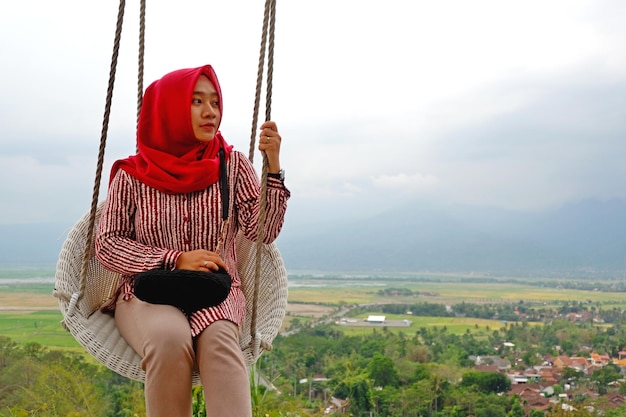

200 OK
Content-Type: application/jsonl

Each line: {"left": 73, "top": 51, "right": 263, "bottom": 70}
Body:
{"left": 111, "top": 65, "right": 232, "bottom": 194}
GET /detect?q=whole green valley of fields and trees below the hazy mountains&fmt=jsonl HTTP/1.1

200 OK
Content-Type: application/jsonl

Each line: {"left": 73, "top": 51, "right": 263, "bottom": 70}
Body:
{"left": 6, "top": 276, "right": 626, "bottom": 417}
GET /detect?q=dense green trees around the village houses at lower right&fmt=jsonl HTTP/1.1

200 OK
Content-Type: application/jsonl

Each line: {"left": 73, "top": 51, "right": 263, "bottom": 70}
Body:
{"left": 249, "top": 320, "right": 626, "bottom": 417}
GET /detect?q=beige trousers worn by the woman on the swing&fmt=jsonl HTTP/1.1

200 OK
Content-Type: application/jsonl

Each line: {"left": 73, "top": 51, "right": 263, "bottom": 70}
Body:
{"left": 115, "top": 297, "right": 252, "bottom": 417}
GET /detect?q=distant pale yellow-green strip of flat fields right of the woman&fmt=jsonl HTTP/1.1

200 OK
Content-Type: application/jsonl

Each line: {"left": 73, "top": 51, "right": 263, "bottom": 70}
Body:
{"left": 289, "top": 276, "right": 626, "bottom": 306}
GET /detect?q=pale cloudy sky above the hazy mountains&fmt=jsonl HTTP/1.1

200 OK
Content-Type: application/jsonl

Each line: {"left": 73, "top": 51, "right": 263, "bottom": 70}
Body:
{"left": 0, "top": 0, "right": 626, "bottom": 228}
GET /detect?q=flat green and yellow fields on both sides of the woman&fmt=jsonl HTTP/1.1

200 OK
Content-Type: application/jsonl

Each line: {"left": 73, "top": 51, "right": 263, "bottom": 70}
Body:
{"left": 0, "top": 277, "right": 626, "bottom": 350}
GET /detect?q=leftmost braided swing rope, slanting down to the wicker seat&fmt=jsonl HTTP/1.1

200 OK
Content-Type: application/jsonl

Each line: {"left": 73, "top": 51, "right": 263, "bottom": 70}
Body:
{"left": 70, "top": 0, "right": 126, "bottom": 313}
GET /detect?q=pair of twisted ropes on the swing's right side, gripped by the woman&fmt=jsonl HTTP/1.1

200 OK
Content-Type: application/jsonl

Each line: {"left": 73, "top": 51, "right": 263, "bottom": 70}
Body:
{"left": 249, "top": 0, "right": 276, "bottom": 350}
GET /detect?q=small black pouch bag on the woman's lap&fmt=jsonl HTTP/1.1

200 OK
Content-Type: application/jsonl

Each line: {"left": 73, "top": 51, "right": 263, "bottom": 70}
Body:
{"left": 135, "top": 268, "right": 232, "bottom": 314}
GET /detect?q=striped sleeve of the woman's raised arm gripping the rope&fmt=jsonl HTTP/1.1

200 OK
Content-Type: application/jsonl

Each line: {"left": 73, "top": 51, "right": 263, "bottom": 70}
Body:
{"left": 235, "top": 155, "right": 291, "bottom": 243}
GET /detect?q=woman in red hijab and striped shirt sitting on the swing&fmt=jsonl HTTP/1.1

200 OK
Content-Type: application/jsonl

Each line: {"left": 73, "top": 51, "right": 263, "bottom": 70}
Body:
{"left": 95, "top": 65, "right": 289, "bottom": 417}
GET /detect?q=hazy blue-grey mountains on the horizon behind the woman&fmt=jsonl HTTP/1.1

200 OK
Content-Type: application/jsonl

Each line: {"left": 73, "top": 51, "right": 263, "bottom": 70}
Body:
{"left": 0, "top": 200, "right": 626, "bottom": 277}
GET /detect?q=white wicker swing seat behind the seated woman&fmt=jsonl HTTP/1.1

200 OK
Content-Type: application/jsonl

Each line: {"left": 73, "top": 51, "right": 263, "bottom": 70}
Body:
{"left": 54, "top": 203, "right": 287, "bottom": 385}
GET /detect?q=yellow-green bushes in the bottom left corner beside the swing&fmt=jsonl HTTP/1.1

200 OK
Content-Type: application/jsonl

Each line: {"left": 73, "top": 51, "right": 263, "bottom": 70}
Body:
{"left": 0, "top": 336, "right": 145, "bottom": 417}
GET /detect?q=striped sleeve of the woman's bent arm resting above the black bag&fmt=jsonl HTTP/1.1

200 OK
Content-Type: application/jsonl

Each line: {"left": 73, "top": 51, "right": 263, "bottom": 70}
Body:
{"left": 95, "top": 170, "right": 181, "bottom": 275}
